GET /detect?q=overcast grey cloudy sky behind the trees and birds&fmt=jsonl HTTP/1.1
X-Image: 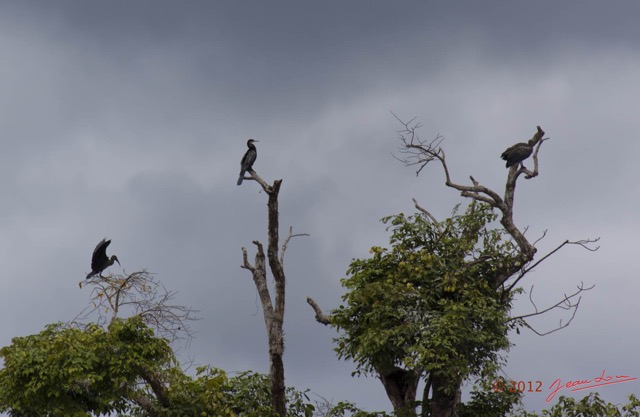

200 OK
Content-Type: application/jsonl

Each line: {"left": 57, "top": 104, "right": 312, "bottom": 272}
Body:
{"left": 0, "top": 1, "right": 640, "bottom": 410}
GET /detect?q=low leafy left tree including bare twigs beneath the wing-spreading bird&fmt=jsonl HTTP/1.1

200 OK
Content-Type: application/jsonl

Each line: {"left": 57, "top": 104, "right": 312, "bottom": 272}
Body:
{"left": 0, "top": 271, "right": 344, "bottom": 417}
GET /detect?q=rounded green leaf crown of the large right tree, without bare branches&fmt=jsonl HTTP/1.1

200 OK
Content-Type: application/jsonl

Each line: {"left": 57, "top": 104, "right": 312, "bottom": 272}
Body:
{"left": 331, "top": 203, "right": 518, "bottom": 385}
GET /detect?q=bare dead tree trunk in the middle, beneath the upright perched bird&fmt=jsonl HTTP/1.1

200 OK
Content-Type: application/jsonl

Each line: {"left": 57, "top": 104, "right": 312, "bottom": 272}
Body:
{"left": 240, "top": 170, "right": 303, "bottom": 417}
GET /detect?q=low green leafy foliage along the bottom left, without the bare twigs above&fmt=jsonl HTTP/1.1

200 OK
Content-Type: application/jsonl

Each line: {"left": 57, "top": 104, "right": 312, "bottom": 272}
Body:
{"left": 0, "top": 316, "right": 322, "bottom": 417}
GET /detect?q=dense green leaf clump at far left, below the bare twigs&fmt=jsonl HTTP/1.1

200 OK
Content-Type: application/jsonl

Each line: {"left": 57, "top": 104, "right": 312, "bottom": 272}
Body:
{"left": 0, "top": 317, "right": 174, "bottom": 416}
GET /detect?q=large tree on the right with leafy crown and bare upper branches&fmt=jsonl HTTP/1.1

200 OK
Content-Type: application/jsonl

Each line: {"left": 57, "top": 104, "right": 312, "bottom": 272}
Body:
{"left": 307, "top": 119, "right": 593, "bottom": 417}
